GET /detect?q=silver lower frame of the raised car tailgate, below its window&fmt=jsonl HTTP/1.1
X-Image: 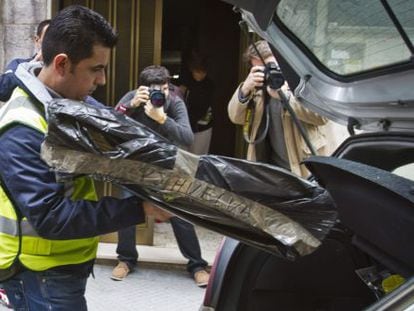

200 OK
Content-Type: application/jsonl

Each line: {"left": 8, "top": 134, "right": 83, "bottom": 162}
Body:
{"left": 223, "top": 1, "right": 414, "bottom": 131}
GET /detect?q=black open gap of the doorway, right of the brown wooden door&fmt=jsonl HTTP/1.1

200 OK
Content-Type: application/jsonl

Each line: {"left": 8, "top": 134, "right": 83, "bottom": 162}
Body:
{"left": 161, "top": 0, "right": 240, "bottom": 156}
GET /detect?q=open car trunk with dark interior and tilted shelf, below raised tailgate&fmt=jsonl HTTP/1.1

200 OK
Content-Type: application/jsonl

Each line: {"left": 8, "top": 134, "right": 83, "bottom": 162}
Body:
{"left": 210, "top": 132, "right": 414, "bottom": 311}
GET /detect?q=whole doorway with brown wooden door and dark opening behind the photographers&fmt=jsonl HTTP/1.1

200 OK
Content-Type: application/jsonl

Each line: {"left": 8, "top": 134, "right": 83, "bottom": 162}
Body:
{"left": 52, "top": 0, "right": 244, "bottom": 156}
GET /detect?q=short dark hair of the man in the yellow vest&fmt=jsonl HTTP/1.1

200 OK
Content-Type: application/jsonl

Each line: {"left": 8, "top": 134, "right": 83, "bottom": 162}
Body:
{"left": 42, "top": 5, "right": 117, "bottom": 66}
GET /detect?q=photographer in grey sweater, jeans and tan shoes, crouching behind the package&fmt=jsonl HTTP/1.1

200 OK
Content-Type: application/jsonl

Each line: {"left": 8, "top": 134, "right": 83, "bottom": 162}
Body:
{"left": 111, "top": 66, "right": 209, "bottom": 287}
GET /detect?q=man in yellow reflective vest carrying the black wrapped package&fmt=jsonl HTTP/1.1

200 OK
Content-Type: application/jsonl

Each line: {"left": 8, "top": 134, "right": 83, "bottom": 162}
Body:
{"left": 0, "top": 6, "right": 167, "bottom": 310}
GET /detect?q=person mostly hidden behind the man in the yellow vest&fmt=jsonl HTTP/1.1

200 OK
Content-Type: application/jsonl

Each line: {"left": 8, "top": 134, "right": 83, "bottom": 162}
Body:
{"left": 0, "top": 19, "right": 50, "bottom": 102}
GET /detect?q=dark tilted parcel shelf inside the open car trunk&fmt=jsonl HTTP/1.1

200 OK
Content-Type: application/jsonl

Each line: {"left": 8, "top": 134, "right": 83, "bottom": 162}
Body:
{"left": 306, "top": 155, "right": 414, "bottom": 277}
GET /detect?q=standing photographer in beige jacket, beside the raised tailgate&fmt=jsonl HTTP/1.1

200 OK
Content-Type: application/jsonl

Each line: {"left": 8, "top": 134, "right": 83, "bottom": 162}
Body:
{"left": 228, "top": 40, "right": 328, "bottom": 177}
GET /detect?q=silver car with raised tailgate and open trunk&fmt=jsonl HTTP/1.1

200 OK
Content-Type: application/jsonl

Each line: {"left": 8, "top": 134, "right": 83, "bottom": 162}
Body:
{"left": 200, "top": 0, "right": 414, "bottom": 311}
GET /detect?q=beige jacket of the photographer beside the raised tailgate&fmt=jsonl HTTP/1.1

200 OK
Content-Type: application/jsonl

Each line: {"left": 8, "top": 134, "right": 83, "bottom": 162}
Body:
{"left": 227, "top": 85, "right": 333, "bottom": 177}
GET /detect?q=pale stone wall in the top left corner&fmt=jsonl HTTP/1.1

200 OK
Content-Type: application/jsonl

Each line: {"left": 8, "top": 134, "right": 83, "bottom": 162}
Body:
{"left": 0, "top": 0, "right": 52, "bottom": 72}
